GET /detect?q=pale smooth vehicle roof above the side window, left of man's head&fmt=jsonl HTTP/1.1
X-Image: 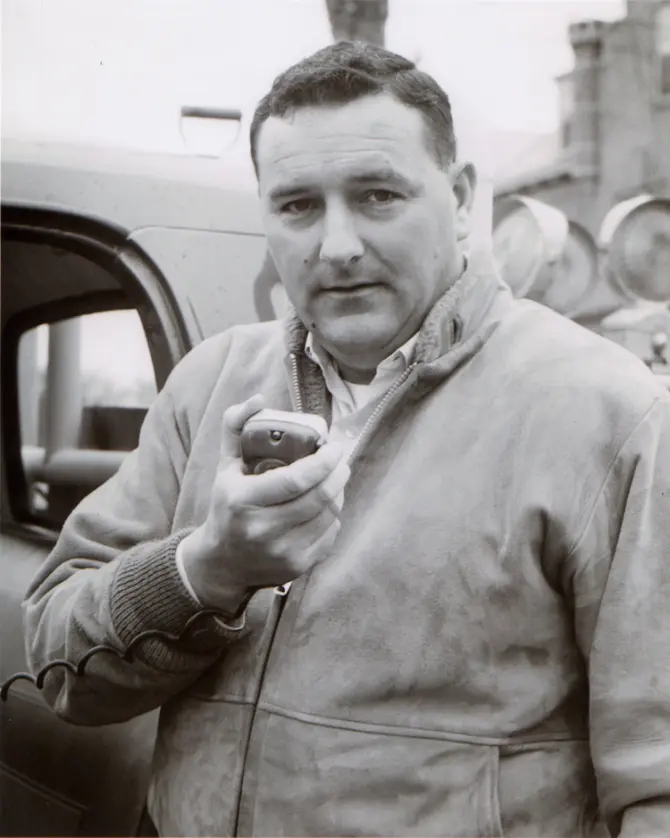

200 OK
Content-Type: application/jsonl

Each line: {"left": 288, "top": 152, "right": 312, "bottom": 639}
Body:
{"left": 2, "top": 140, "right": 262, "bottom": 235}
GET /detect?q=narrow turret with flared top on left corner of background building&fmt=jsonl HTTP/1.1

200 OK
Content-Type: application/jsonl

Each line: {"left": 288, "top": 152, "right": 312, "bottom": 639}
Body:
{"left": 565, "top": 20, "right": 605, "bottom": 177}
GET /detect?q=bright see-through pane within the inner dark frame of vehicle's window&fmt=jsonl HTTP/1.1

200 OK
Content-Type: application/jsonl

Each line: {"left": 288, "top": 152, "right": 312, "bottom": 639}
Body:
{"left": 18, "top": 310, "right": 157, "bottom": 520}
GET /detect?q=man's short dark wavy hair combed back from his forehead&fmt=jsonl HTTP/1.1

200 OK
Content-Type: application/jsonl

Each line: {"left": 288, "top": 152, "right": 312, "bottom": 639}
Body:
{"left": 250, "top": 41, "right": 456, "bottom": 175}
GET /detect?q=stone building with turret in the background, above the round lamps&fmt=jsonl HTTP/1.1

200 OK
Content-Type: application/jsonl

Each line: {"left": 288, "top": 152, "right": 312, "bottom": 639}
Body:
{"left": 496, "top": 0, "right": 670, "bottom": 233}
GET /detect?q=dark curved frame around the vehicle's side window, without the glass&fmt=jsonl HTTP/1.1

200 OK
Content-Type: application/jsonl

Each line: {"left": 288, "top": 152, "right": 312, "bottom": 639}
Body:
{"left": 0, "top": 204, "right": 191, "bottom": 530}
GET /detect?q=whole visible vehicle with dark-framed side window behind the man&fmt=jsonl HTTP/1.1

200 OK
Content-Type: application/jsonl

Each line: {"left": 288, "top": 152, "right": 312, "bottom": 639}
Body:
{"left": 0, "top": 135, "right": 283, "bottom": 836}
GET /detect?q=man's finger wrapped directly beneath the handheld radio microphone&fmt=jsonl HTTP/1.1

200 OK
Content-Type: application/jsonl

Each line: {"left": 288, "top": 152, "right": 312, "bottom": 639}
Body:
{"left": 245, "top": 442, "right": 343, "bottom": 506}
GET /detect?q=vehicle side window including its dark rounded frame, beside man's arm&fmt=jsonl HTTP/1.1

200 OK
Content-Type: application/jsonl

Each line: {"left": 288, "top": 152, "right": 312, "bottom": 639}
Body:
{"left": 1, "top": 210, "right": 188, "bottom": 530}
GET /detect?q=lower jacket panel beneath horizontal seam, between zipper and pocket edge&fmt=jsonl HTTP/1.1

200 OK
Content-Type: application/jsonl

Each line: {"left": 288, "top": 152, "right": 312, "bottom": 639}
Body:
{"left": 239, "top": 708, "right": 502, "bottom": 838}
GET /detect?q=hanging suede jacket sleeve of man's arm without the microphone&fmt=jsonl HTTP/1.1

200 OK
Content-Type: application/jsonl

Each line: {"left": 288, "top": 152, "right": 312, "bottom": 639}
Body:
{"left": 570, "top": 395, "right": 670, "bottom": 838}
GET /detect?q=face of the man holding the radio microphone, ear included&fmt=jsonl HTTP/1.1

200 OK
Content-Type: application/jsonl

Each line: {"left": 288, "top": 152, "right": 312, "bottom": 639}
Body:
{"left": 257, "top": 95, "right": 474, "bottom": 369}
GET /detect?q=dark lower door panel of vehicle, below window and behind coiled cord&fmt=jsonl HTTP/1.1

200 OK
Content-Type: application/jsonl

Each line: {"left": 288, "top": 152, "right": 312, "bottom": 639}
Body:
{"left": 0, "top": 531, "right": 157, "bottom": 836}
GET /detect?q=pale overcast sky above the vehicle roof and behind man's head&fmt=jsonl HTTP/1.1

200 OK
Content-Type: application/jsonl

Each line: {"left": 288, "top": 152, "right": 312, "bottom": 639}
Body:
{"left": 2, "top": 0, "right": 625, "bottom": 156}
